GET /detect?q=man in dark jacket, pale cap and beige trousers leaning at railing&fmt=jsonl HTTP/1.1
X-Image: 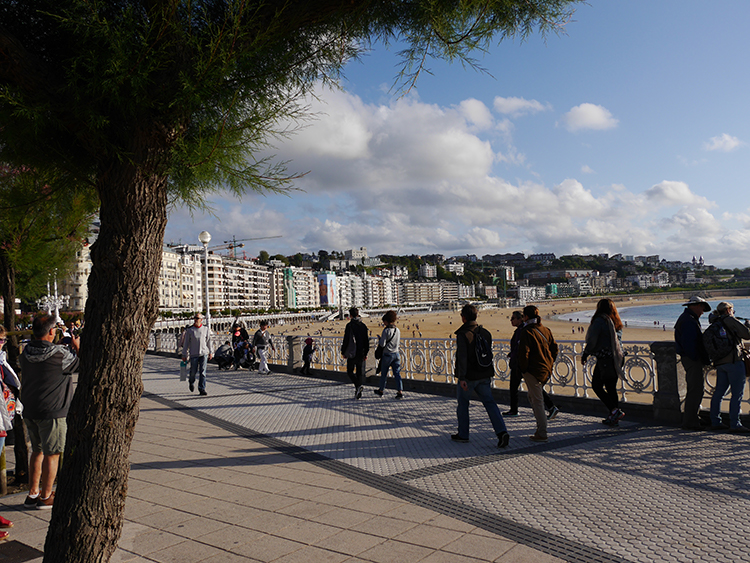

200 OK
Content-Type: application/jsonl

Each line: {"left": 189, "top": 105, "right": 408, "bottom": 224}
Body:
{"left": 674, "top": 295, "right": 711, "bottom": 430}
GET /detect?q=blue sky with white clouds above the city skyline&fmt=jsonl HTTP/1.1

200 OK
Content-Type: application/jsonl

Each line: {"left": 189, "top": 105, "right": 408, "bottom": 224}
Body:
{"left": 165, "top": 0, "right": 750, "bottom": 268}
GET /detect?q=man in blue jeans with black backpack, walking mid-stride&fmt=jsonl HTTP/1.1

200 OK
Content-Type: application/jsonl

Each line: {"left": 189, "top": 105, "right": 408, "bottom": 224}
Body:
{"left": 451, "top": 304, "right": 510, "bottom": 448}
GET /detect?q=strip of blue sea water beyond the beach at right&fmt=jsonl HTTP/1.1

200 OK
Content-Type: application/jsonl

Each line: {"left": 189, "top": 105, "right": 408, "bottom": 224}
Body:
{"left": 555, "top": 297, "right": 750, "bottom": 330}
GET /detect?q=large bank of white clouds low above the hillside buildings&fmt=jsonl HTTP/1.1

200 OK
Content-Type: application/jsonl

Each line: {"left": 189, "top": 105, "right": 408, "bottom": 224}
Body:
{"left": 167, "top": 87, "right": 750, "bottom": 265}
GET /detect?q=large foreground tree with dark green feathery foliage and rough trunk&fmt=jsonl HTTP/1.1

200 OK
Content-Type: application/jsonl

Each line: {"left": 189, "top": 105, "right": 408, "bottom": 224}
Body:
{"left": 0, "top": 0, "right": 572, "bottom": 563}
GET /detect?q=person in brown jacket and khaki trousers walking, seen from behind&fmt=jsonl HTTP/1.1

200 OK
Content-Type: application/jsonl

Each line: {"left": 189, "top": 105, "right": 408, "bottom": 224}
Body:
{"left": 518, "top": 305, "right": 558, "bottom": 442}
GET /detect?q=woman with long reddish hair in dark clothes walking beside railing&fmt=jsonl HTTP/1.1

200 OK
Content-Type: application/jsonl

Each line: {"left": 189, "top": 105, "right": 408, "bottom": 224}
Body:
{"left": 581, "top": 298, "right": 625, "bottom": 426}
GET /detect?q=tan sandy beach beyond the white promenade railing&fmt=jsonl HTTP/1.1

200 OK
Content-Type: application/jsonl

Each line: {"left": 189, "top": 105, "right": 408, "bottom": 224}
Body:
{"left": 271, "top": 298, "right": 684, "bottom": 343}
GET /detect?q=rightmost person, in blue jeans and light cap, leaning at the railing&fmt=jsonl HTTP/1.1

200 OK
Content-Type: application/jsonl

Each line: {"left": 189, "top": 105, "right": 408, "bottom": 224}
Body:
{"left": 706, "top": 301, "right": 750, "bottom": 434}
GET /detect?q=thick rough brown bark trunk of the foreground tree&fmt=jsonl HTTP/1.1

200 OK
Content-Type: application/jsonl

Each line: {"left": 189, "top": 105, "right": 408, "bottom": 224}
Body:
{"left": 44, "top": 134, "right": 167, "bottom": 563}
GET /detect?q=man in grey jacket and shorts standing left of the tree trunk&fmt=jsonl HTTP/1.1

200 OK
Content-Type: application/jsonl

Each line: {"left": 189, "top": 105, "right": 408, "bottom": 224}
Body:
{"left": 21, "top": 315, "right": 80, "bottom": 510}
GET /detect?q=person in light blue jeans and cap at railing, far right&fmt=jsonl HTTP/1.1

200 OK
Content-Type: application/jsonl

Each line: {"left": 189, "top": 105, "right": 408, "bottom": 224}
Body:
{"left": 703, "top": 301, "right": 750, "bottom": 434}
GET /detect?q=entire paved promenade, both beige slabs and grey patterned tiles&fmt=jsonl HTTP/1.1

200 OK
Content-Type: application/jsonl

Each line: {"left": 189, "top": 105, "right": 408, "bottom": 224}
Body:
{"left": 0, "top": 356, "right": 750, "bottom": 563}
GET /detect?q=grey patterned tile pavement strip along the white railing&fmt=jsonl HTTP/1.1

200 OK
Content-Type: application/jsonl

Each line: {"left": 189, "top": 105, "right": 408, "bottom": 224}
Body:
{"left": 143, "top": 355, "right": 750, "bottom": 563}
